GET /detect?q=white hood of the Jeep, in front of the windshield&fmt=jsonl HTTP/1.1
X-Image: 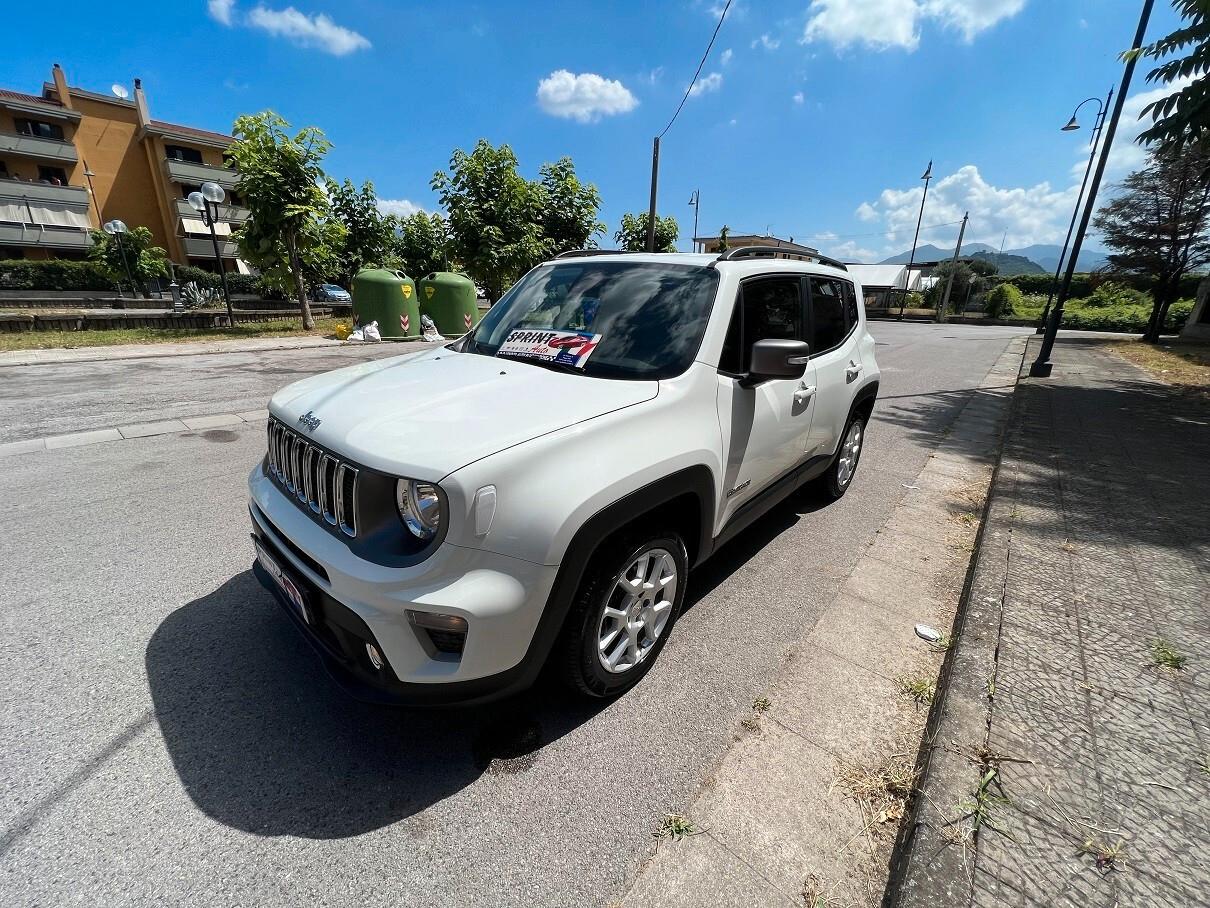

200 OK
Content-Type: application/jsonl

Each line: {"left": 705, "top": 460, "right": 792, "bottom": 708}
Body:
{"left": 269, "top": 346, "right": 658, "bottom": 482}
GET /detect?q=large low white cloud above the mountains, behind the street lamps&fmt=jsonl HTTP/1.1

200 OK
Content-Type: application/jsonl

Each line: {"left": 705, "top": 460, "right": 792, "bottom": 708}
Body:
{"left": 857, "top": 163, "right": 1079, "bottom": 254}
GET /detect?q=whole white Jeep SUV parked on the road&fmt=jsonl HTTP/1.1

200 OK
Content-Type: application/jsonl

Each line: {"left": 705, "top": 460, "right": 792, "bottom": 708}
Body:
{"left": 248, "top": 247, "right": 878, "bottom": 702}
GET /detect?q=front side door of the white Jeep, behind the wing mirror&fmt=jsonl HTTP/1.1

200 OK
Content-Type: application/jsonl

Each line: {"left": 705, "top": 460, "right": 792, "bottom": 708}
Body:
{"left": 715, "top": 275, "right": 816, "bottom": 529}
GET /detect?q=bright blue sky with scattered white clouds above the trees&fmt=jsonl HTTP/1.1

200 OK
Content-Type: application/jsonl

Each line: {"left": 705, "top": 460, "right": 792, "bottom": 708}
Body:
{"left": 7, "top": 0, "right": 1176, "bottom": 260}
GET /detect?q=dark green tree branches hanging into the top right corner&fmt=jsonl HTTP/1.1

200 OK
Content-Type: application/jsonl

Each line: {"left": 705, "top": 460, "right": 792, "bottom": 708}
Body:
{"left": 1139, "top": 0, "right": 1210, "bottom": 151}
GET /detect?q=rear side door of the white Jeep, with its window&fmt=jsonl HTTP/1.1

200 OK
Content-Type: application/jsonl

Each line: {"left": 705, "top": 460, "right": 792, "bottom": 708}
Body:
{"left": 807, "top": 276, "right": 864, "bottom": 456}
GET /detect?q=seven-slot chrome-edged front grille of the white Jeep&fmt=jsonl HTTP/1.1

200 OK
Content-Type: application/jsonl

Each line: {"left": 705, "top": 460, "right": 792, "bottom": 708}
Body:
{"left": 269, "top": 419, "right": 357, "bottom": 536}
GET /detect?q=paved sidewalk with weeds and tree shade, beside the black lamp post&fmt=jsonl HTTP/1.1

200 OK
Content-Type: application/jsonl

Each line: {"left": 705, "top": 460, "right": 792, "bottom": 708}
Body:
{"left": 895, "top": 339, "right": 1210, "bottom": 908}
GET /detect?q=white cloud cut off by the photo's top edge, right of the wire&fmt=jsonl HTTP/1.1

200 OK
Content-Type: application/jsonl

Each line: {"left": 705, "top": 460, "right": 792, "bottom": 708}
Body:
{"left": 801, "top": 0, "right": 1027, "bottom": 52}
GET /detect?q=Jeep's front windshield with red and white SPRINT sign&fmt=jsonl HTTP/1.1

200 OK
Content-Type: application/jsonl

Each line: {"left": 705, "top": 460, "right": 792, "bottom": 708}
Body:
{"left": 462, "top": 260, "right": 719, "bottom": 380}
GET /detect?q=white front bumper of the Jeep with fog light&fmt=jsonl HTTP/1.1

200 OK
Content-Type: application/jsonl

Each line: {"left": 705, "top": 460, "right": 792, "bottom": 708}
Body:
{"left": 248, "top": 466, "right": 558, "bottom": 703}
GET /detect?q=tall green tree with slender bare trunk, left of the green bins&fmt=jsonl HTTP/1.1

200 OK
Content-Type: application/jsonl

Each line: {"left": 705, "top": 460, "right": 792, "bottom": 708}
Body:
{"left": 226, "top": 110, "right": 344, "bottom": 328}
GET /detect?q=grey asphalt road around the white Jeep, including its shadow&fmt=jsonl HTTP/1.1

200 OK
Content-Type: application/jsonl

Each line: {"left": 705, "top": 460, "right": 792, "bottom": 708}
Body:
{"left": 0, "top": 323, "right": 1021, "bottom": 908}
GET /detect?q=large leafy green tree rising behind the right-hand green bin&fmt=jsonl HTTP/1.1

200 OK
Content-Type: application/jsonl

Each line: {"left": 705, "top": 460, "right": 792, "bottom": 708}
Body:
{"left": 432, "top": 139, "right": 546, "bottom": 303}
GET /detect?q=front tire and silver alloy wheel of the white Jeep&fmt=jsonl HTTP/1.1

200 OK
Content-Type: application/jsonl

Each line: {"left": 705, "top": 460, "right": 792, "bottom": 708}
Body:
{"left": 560, "top": 529, "right": 688, "bottom": 697}
